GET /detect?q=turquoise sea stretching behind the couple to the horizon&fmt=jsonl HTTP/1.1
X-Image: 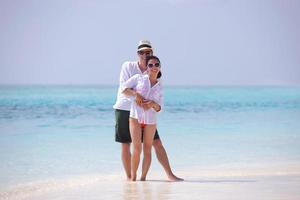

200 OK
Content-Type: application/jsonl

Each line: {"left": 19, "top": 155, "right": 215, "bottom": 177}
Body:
{"left": 0, "top": 86, "right": 300, "bottom": 190}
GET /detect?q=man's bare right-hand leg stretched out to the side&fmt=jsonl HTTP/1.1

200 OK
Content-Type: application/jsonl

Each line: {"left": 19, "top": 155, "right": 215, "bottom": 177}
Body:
{"left": 153, "top": 139, "right": 183, "bottom": 181}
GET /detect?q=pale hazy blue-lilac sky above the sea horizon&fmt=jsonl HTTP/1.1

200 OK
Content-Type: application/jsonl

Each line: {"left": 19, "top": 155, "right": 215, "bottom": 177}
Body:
{"left": 0, "top": 0, "right": 300, "bottom": 85}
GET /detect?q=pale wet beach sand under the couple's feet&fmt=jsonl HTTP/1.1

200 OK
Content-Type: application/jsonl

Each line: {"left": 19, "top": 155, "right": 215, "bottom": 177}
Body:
{"left": 0, "top": 165, "right": 300, "bottom": 200}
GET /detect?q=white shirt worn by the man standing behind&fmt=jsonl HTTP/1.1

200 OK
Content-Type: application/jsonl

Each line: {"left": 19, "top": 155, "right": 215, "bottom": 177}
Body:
{"left": 113, "top": 61, "right": 143, "bottom": 111}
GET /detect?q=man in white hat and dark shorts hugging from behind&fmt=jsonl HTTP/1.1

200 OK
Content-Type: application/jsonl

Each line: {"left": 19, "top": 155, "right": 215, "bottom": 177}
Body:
{"left": 113, "top": 40, "right": 183, "bottom": 181}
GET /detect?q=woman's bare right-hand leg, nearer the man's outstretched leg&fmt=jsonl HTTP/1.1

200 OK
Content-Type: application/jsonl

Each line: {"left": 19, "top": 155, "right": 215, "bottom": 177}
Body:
{"left": 141, "top": 125, "right": 156, "bottom": 181}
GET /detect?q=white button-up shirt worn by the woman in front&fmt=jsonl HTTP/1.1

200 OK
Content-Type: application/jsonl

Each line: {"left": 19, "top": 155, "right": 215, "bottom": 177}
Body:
{"left": 122, "top": 74, "right": 163, "bottom": 124}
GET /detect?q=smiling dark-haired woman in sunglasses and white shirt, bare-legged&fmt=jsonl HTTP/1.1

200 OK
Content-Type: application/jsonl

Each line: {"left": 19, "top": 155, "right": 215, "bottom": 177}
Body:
{"left": 123, "top": 56, "right": 163, "bottom": 181}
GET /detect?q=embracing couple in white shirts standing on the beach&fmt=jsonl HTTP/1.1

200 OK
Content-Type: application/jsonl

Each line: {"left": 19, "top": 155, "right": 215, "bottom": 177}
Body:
{"left": 114, "top": 40, "right": 183, "bottom": 181}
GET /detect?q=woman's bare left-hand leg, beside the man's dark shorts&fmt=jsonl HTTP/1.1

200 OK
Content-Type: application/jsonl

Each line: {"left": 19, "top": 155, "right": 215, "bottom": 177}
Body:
{"left": 129, "top": 118, "right": 142, "bottom": 181}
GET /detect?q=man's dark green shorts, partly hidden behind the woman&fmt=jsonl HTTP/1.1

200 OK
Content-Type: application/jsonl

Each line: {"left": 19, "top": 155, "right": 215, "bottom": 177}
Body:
{"left": 115, "top": 109, "right": 159, "bottom": 143}
